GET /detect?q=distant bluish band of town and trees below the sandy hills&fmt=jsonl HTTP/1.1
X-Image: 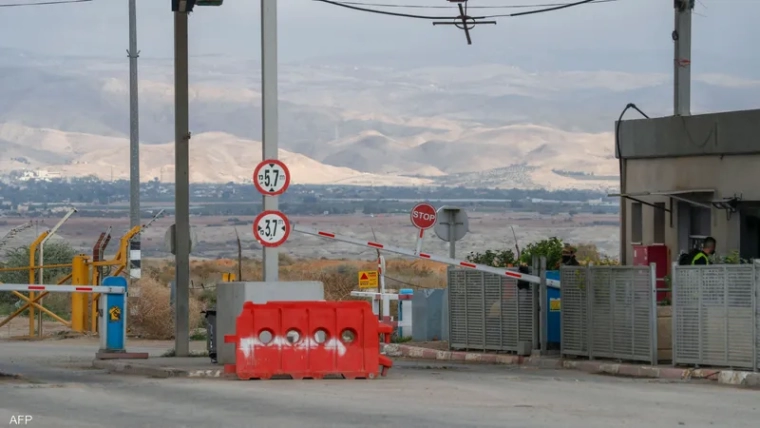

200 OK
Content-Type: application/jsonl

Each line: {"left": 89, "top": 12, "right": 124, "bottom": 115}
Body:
{"left": 0, "top": 171, "right": 619, "bottom": 218}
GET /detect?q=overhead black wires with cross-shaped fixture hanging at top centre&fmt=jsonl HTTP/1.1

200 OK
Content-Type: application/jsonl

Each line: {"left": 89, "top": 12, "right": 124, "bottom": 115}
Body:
{"left": 314, "top": 0, "right": 619, "bottom": 45}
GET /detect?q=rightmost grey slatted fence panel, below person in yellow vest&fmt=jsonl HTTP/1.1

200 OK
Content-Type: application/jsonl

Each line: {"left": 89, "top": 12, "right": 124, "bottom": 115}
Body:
{"left": 672, "top": 264, "right": 760, "bottom": 370}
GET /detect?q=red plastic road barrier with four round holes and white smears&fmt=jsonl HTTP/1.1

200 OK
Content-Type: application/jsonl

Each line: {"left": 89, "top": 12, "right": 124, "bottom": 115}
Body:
{"left": 224, "top": 301, "right": 393, "bottom": 380}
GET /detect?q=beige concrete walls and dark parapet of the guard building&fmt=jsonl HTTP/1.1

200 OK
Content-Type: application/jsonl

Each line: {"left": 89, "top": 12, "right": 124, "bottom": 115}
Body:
{"left": 616, "top": 110, "right": 760, "bottom": 263}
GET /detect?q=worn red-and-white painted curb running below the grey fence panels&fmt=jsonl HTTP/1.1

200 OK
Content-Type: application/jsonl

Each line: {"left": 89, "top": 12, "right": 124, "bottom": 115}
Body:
{"left": 383, "top": 343, "right": 760, "bottom": 388}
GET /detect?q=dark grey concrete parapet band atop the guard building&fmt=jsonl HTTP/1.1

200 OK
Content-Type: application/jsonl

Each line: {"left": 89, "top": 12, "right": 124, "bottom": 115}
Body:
{"left": 616, "top": 110, "right": 760, "bottom": 159}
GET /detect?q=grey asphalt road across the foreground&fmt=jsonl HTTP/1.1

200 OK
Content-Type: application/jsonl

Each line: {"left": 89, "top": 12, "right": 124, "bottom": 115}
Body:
{"left": 0, "top": 342, "right": 760, "bottom": 428}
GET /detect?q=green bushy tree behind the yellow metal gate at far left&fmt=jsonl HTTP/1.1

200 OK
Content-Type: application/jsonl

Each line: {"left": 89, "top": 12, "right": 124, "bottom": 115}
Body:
{"left": 0, "top": 242, "right": 77, "bottom": 302}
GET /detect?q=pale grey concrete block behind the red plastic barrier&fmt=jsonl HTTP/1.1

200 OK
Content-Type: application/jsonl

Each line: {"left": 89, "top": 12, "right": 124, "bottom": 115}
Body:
{"left": 216, "top": 281, "right": 325, "bottom": 364}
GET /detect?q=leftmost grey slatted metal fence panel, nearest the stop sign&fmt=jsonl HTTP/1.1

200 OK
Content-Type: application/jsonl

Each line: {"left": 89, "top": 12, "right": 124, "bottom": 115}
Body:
{"left": 448, "top": 267, "right": 538, "bottom": 352}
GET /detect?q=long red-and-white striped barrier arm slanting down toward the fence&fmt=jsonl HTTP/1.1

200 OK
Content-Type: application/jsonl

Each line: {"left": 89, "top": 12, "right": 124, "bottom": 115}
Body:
{"left": 293, "top": 224, "right": 559, "bottom": 288}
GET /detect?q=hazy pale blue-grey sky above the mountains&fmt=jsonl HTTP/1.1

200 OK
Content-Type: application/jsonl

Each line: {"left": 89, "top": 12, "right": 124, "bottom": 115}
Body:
{"left": 0, "top": 0, "right": 760, "bottom": 75}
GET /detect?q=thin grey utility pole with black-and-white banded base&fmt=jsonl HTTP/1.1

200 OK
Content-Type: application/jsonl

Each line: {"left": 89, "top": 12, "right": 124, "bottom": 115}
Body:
{"left": 127, "top": 0, "right": 142, "bottom": 279}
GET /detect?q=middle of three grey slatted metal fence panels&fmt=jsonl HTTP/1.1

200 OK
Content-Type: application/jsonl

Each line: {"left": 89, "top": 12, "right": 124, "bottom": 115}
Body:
{"left": 560, "top": 266, "right": 657, "bottom": 364}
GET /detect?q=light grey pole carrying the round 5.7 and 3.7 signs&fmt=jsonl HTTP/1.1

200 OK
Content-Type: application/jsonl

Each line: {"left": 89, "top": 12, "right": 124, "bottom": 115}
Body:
{"left": 261, "top": 0, "right": 280, "bottom": 282}
